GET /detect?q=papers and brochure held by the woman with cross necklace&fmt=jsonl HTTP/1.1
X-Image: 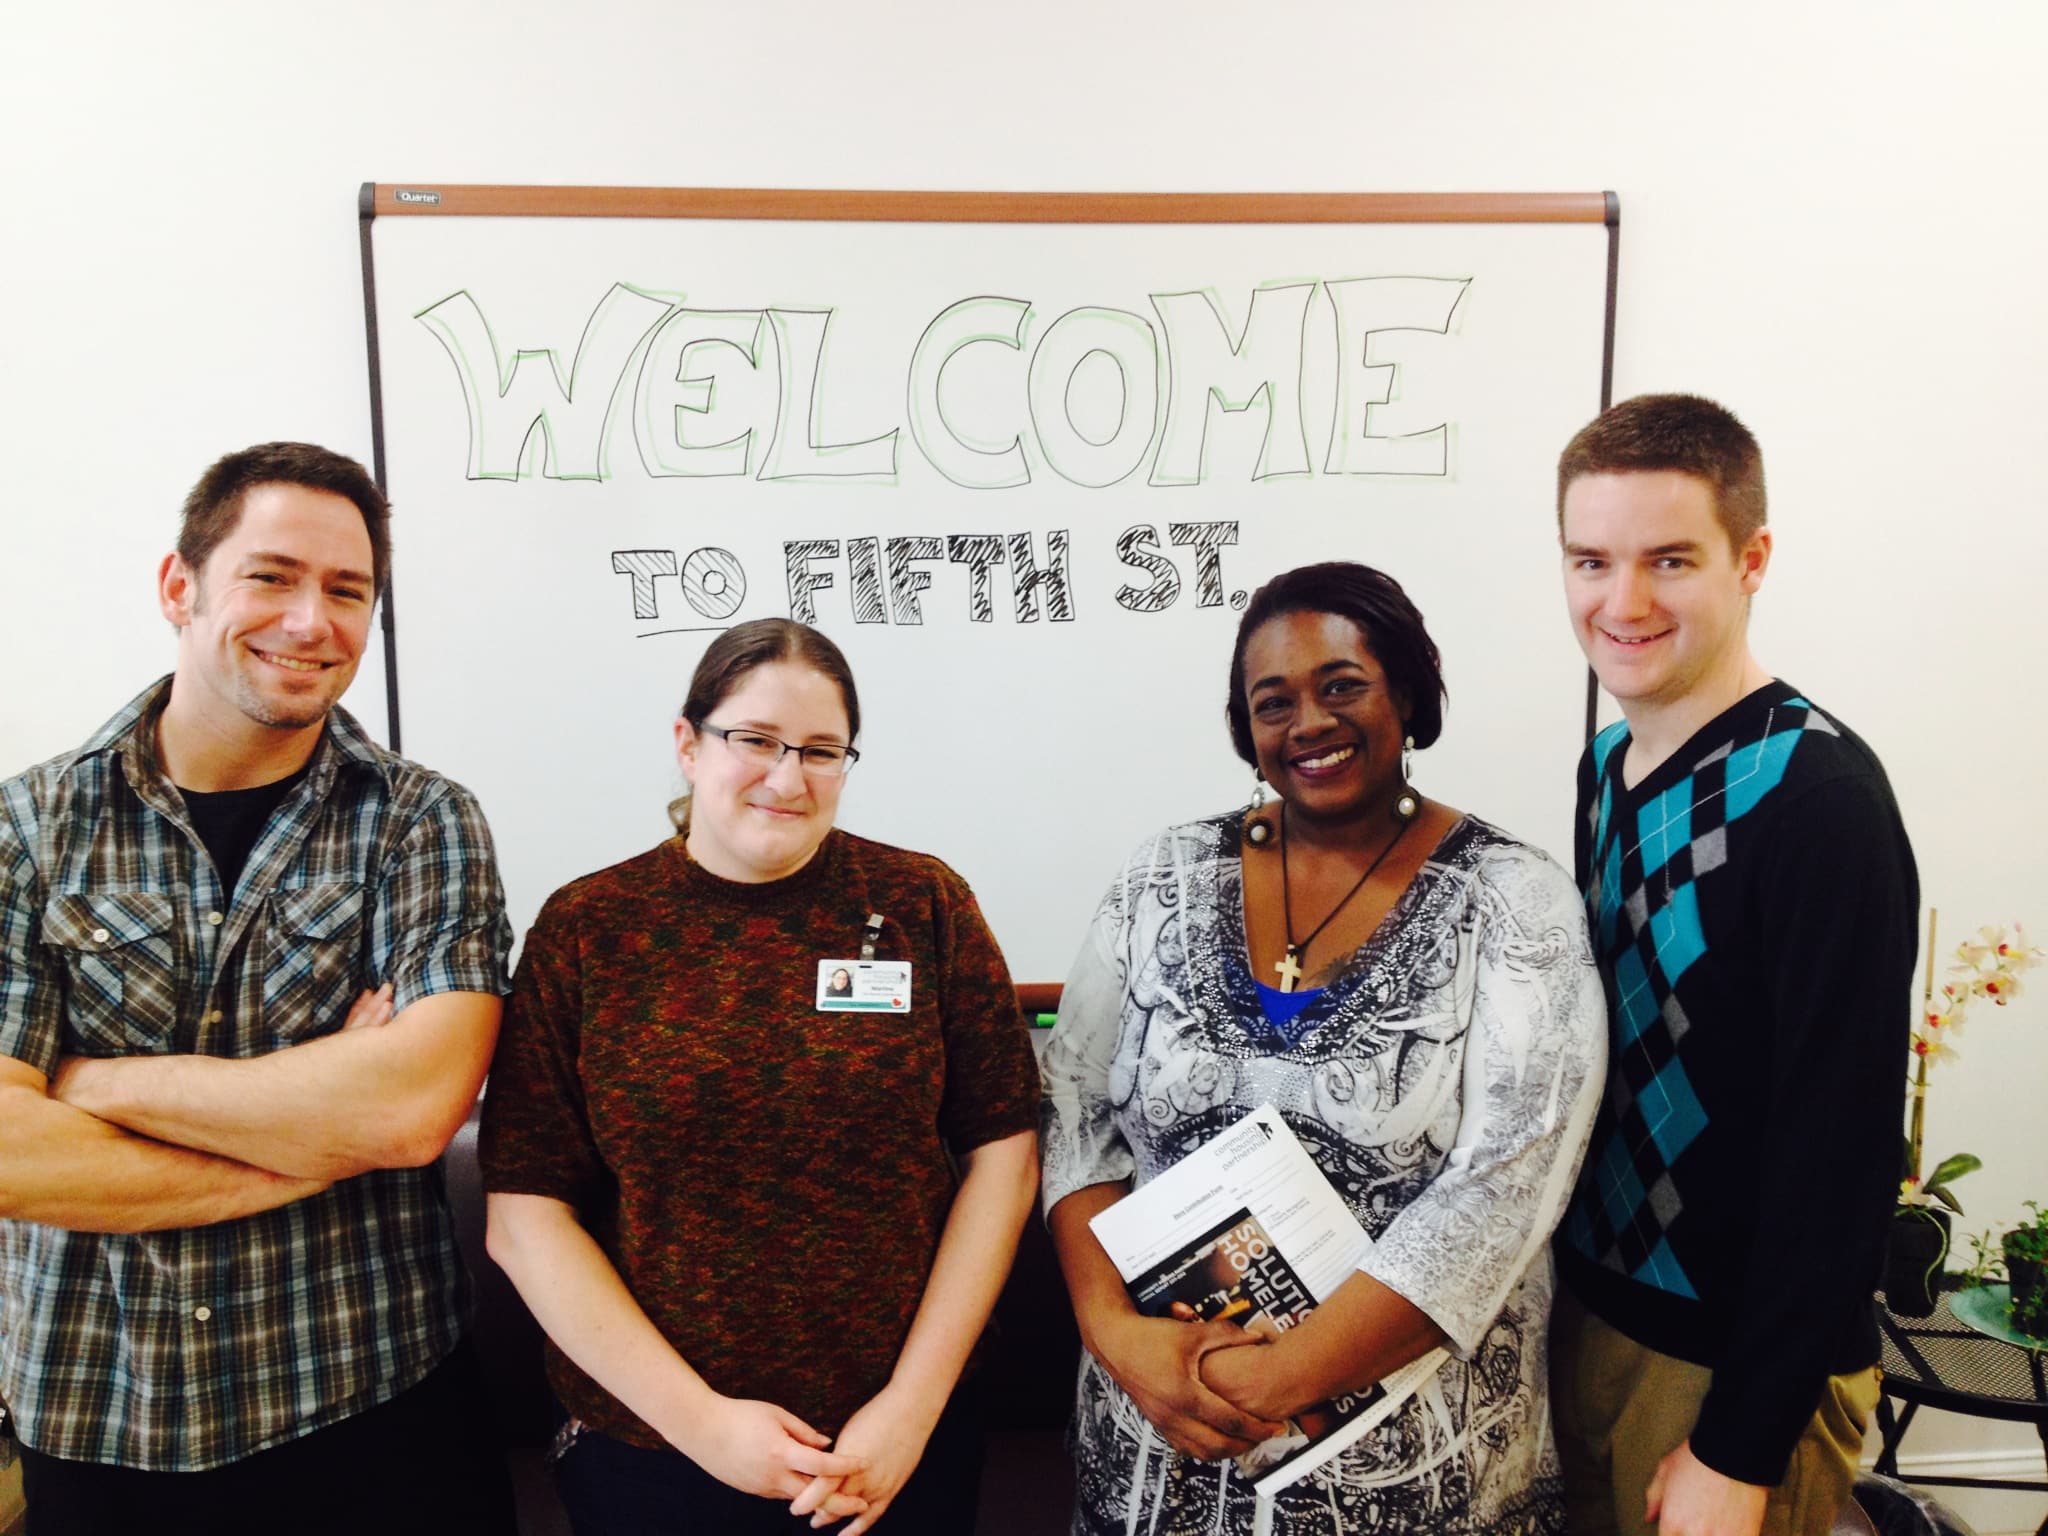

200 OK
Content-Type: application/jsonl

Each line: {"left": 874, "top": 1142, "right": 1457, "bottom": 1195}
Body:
{"left": 1090, "top": 1104, "right": 1446, "bottom": 1497}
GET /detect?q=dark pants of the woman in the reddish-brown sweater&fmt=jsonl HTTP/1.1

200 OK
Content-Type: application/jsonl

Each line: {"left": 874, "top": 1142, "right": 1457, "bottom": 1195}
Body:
{"left": 552, "top": 1386, "right": 981, "bottom": 1536}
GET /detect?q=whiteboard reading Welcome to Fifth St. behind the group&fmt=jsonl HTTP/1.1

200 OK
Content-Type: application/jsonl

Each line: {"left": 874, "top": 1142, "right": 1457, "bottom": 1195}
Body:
{"left": 362, "top": 184, "right": 1614, "bottom": 981}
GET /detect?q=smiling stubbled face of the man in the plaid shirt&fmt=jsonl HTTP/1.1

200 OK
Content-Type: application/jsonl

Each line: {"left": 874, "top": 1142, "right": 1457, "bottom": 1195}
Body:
{"left": 158, "top": 483, "right": 377, "bottom": 748}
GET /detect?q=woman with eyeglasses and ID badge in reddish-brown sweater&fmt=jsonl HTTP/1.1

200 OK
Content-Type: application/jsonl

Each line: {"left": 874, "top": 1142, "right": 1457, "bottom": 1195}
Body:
{"left": 481, "top": 618, "right": 1038, "bottom": 1536}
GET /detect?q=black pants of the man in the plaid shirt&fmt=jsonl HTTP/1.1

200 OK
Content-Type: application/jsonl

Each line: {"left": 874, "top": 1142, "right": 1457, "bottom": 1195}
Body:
{"left": 20, "top": 1343, "right": 516, "bottom": 1536}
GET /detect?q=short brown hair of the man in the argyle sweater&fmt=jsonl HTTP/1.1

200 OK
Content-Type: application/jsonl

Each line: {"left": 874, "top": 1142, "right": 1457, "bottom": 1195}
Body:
{"left": 1556, "top": 395, "right": 1765, "bottom": 549}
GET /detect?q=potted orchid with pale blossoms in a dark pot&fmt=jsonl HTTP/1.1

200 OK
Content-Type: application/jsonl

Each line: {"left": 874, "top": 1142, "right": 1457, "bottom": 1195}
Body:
{"left": 1884, "top": 909, "right": 2042, "bottom": 1317}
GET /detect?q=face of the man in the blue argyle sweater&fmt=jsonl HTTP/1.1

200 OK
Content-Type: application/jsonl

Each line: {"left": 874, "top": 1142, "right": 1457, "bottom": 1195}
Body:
{"left": 1563, "top": 469, "right": 1772, "bottom": 723}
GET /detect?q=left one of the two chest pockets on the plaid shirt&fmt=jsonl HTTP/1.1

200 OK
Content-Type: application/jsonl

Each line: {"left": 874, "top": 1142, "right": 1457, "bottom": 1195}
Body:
{"left": 43, "top": 891, "right": 178, "bottom": 1057}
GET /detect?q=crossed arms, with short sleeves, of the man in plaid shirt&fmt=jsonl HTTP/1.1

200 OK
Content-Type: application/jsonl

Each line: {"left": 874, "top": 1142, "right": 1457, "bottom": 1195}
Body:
{"left": 0, "top": 770, "right": 504, "bottom": 1233}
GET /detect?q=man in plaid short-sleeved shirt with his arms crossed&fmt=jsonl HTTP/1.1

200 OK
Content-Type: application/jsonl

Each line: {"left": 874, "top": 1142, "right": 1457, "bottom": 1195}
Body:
{"left": 0, "top": 442, "right": 512, "bottom": 1536}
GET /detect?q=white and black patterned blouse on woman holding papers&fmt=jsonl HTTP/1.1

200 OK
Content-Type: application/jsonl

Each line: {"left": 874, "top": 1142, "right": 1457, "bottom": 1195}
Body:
{"left": 1042, "top": 813, "right": 1606, "bottom": 1536}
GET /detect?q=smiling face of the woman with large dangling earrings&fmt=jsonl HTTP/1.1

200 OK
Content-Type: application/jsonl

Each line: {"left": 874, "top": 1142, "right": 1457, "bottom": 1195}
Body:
{"left": 1243, "top": 612, "right": 1407, "bottom": 823}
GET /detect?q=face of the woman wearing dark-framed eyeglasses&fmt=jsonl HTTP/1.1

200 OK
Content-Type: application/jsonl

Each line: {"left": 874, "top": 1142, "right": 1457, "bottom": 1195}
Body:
{"left": 676, "top": 662, "right": 850, "bottom": 883}
